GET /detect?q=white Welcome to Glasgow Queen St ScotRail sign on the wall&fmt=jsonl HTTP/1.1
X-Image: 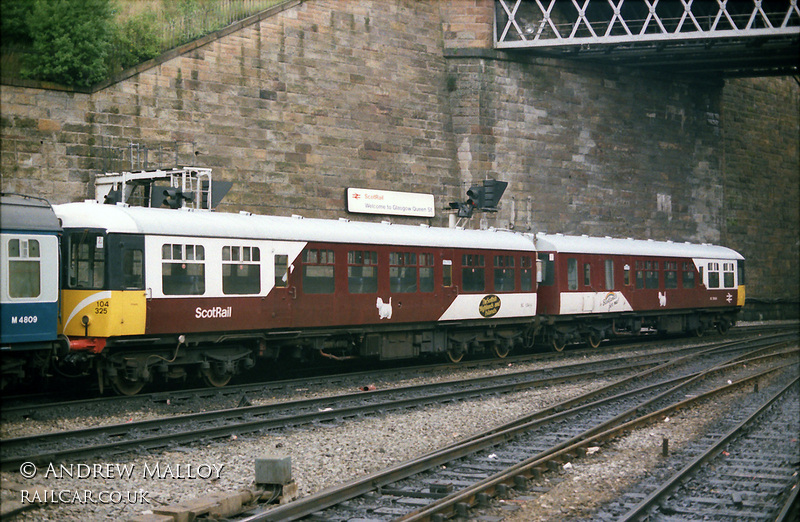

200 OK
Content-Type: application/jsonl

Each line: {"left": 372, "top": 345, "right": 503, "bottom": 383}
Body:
{"left": 347, "top": 187, "right": 436, "bottom": 217}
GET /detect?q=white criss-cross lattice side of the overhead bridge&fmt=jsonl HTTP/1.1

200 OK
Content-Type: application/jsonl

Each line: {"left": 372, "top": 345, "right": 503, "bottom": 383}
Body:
{"left": 495, "top": 0, "right": 800, "bottom": 49}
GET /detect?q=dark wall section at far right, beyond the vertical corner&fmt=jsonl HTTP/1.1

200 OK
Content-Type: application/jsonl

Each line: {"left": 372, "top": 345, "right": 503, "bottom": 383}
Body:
{"left": 722, "top": 78, "right": 800, "bottom": 300}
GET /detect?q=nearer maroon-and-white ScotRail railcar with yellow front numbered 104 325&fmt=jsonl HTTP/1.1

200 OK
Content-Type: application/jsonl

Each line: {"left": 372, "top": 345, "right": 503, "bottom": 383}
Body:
{"left": 56, "top": 202, "right": 536, "bottom": 393}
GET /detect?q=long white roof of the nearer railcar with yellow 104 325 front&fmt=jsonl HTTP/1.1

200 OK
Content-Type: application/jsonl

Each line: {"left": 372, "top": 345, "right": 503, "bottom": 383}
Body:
{"left": 54, "top": 201, "right": 534, "bottom": 252}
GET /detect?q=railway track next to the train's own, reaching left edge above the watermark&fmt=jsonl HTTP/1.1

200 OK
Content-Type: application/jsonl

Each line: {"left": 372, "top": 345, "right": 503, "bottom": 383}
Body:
{"left": 0, "top": 334, "right": 792, "bottom": 469}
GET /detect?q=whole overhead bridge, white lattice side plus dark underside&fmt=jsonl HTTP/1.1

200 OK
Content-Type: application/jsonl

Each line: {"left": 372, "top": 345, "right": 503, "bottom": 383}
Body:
{"left": 494, "top": 0, "right": 800, "bottom": 76}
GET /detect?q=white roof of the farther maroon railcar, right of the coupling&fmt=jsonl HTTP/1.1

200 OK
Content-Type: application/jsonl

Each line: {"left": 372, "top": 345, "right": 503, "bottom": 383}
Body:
{"left": 536, "top": 233, "right": 744, "bottom": 259}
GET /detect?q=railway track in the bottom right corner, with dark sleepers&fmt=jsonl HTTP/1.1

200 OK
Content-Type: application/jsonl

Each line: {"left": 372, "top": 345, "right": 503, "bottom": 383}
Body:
{"left": 599, "top": 377, "right": 800, "bottom": 522}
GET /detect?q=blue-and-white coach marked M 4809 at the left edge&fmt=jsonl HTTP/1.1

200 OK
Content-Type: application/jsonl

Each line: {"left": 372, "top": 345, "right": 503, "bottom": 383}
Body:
{"left": 0, "top": 194, "right": 67, "bottom": 387}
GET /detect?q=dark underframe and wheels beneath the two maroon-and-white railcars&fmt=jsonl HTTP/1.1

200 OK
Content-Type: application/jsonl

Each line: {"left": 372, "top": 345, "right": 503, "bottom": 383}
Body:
{"left": 43, "top": 310, "right": 737, "bottom": 395}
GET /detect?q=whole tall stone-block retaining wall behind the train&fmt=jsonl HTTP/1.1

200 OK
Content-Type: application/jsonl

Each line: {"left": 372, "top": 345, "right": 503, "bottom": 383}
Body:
{"left": 0, "top": 0, "right": 800, "bottom": 298}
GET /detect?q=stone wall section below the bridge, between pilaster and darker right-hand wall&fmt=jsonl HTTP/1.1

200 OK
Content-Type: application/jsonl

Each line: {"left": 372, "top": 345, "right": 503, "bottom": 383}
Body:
{"left": 449, "top": 53, "right": 722, "bottom": 242}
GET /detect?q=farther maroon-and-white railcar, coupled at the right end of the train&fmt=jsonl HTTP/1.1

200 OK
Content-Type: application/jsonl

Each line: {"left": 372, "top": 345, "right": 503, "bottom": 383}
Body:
{"left": 536, "top": 234, "right": 745, "bottom": 351}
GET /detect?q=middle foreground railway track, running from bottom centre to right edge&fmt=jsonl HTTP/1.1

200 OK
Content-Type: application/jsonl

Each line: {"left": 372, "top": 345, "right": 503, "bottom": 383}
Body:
{"left": 227, "top": 336, "right": 798, "bottom": 521}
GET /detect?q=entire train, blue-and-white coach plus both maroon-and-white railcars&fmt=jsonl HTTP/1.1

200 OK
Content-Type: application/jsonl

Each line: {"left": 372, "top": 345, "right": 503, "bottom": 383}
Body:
{"left": 0, "top": 195, "right": 745, "bottom": 394}
